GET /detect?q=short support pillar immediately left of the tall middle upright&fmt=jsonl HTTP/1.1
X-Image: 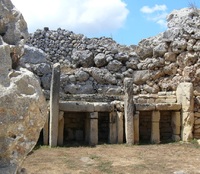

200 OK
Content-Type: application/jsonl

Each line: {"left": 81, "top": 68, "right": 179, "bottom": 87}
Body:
{"left": 117, "top": 112, "right": 124, "bottom": 144}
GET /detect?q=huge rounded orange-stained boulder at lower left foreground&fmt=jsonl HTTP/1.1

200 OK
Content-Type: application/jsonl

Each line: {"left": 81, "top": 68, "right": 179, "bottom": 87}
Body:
{"left": 0, "top": 69, "right": 47, "bottom": 173}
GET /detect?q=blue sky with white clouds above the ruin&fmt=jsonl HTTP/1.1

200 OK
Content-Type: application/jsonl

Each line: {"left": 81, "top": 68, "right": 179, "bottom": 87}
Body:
{"left": 12, "top": 0, "right": 200, "bottom": 45}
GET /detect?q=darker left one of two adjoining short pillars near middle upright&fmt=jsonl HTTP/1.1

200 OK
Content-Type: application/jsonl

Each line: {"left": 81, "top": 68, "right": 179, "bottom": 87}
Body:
{"left": 109, "top": 112, "right": 117, "bottom": 144}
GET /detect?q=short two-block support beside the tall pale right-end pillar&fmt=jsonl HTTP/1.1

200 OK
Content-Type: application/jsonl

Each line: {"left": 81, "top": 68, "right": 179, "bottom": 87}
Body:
{"left": 171, "top": 112, "right": 181, "bottom": 141}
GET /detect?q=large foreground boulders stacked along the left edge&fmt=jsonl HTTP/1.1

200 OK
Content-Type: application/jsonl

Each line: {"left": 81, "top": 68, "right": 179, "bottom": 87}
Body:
{"left": 0, "top": 0, "right": 47, "bottom": 174}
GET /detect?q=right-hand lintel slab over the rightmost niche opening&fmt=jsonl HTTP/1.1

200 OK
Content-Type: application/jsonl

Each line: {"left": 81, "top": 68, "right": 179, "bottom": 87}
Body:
{"left": 156, "top": 103, "right": 181, "bottom": 111}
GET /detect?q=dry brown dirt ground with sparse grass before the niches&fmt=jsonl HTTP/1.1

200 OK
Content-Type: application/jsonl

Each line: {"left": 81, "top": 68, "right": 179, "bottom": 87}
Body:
{"left": 22, "top": 143, "right": 200, "bottom": 174}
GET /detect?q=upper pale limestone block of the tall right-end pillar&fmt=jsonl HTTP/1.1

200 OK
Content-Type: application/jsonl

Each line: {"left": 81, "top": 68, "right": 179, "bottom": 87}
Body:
{"left": 176, "top": 82, "right": 194, "bottom": 112}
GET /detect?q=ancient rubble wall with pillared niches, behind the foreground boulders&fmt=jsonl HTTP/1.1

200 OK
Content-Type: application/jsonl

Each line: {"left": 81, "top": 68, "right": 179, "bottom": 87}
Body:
{"left": 20, "top": 8, "right": 200, "bottom": 146}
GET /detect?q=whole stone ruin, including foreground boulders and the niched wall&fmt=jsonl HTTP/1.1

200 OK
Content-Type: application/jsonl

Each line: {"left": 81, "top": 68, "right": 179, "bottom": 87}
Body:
{"left": 0, "top": 0, "right": 200, "bottom": 173}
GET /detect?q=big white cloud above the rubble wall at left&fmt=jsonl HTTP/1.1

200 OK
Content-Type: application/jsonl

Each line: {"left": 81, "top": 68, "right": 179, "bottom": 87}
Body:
{"left": 12, "top": 0, "right": 129, "bottom": 35}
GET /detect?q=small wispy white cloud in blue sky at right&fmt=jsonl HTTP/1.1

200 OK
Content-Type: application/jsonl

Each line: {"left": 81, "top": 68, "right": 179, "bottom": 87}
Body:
{"left": 140, "top": 4, "right": 168, "bottom": 28}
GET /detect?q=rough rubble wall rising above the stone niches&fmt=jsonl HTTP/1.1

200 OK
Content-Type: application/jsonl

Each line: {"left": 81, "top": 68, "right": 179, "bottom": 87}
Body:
{"left": 21, "top": 8, "right": 200, "bottom": 138}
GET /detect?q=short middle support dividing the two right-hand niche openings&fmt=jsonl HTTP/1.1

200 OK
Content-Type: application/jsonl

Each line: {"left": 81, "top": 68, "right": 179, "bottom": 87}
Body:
{"left": 151, "top": 111, "right": 160, "bottom": 143}
